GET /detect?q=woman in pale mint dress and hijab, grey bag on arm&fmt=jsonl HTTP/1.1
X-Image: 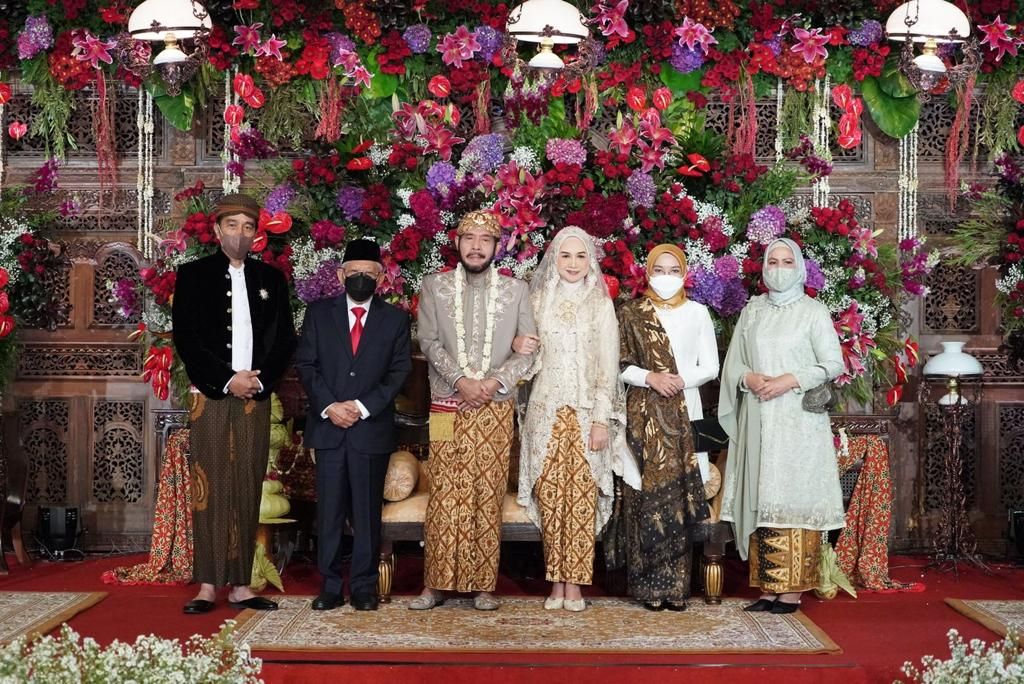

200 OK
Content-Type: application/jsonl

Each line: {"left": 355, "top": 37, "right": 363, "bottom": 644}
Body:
{"left": 718, "top": 239, "right": 844, "bottom": 613}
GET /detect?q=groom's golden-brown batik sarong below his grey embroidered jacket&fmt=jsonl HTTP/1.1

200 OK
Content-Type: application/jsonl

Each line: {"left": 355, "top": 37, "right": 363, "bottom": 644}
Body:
{"left": 423, "top": 401, "right": 514, "bottom": 592}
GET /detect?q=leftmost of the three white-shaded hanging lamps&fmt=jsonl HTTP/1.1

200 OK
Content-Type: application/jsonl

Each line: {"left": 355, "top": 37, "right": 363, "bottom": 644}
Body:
{"left": 118, "top": 0, "right": 213, "bottom": 96}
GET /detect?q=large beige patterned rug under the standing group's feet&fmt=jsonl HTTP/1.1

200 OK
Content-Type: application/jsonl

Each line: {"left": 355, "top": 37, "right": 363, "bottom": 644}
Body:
{"left": 237, "top": 596, "right": 840, "bottom": 653}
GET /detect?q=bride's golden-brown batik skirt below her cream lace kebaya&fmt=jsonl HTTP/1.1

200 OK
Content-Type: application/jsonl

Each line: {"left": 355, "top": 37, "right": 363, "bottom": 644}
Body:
{"left": 534, "top": 407, "right": 597, "bottom": 585}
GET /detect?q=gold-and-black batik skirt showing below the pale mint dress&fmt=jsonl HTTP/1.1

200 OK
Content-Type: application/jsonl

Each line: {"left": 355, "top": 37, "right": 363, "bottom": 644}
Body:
{"left": 749, "top": 527, "right": 821, "bottom": 594}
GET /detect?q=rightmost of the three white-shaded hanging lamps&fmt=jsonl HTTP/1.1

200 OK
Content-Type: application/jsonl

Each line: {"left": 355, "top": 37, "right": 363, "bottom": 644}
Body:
{"left": 886, "top": 0, "right": 981, "bottom": 97}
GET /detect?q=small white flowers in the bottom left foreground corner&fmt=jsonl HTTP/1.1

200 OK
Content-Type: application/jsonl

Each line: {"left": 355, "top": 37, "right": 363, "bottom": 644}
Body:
{"left": 0, "top": 619, "right": 262, "bottom": 684}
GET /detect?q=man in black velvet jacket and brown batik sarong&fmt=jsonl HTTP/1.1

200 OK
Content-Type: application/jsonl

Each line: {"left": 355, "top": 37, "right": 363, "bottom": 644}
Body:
{"left": 172, "top": 195, "right": 295, "bottom": 614}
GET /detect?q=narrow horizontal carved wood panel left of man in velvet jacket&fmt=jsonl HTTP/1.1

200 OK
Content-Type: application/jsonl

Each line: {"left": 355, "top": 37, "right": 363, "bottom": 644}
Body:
{"left": 17, "top": 342, "right": 142, "bottom": 380}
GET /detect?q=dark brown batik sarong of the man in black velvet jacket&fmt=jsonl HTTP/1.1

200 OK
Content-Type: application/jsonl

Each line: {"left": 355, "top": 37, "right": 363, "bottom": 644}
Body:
{"left": 189, "top": 394, "right": 270, "bottom": 587}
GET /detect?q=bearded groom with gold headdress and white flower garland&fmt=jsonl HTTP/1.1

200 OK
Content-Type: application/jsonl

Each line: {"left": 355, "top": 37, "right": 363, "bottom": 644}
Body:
{"left": 409, "top": 211, "right": 537, "bottom": 610}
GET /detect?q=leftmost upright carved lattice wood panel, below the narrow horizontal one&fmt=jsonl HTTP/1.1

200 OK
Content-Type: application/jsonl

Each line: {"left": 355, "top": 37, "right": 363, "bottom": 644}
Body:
{"left": 18, "top": 399, "right": 71, "bottom": 504}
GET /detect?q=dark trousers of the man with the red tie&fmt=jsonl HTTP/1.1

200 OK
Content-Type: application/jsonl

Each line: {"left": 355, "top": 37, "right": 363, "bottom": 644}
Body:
{"left": 316, "top": 443, "right": 390, "bottom": 595}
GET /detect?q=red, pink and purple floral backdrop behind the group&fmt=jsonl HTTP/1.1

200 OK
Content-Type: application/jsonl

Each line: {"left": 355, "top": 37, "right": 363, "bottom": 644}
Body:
{"left": 6, "top": 0, "right": 1022, "bottom": 402}
